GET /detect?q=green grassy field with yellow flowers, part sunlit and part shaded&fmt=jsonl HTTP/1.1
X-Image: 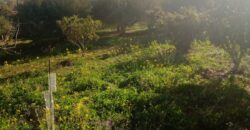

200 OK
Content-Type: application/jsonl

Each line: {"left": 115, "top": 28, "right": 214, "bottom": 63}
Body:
{"left": 0, "top": 30, "right": 250, "bottom": 130}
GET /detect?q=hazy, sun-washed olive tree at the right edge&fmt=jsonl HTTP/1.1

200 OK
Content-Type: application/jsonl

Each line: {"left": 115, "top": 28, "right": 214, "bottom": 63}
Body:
{"left": 207, "top": 0, "right": 250, "bottom": 74}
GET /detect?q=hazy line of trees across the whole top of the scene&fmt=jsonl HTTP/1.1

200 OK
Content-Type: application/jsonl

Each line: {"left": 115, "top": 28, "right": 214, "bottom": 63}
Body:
{"left": 0, "top": 0, "right": 250, "bottom": 71}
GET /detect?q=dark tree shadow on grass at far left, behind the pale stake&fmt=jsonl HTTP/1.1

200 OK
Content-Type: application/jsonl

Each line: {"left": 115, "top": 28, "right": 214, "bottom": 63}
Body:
{"left": 0, "top": 38, "right": 76, "bottom": 65}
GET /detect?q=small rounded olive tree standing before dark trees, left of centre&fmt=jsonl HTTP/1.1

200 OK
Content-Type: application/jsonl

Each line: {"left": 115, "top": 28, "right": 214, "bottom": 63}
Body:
{"left": 58, "top": 16, "right": 102, "bottom": 51}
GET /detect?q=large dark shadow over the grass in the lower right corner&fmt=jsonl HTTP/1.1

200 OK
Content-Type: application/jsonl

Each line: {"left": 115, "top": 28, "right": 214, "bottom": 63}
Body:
{"left": 131, "top": 85, "right": 250, "bottom": 130}
